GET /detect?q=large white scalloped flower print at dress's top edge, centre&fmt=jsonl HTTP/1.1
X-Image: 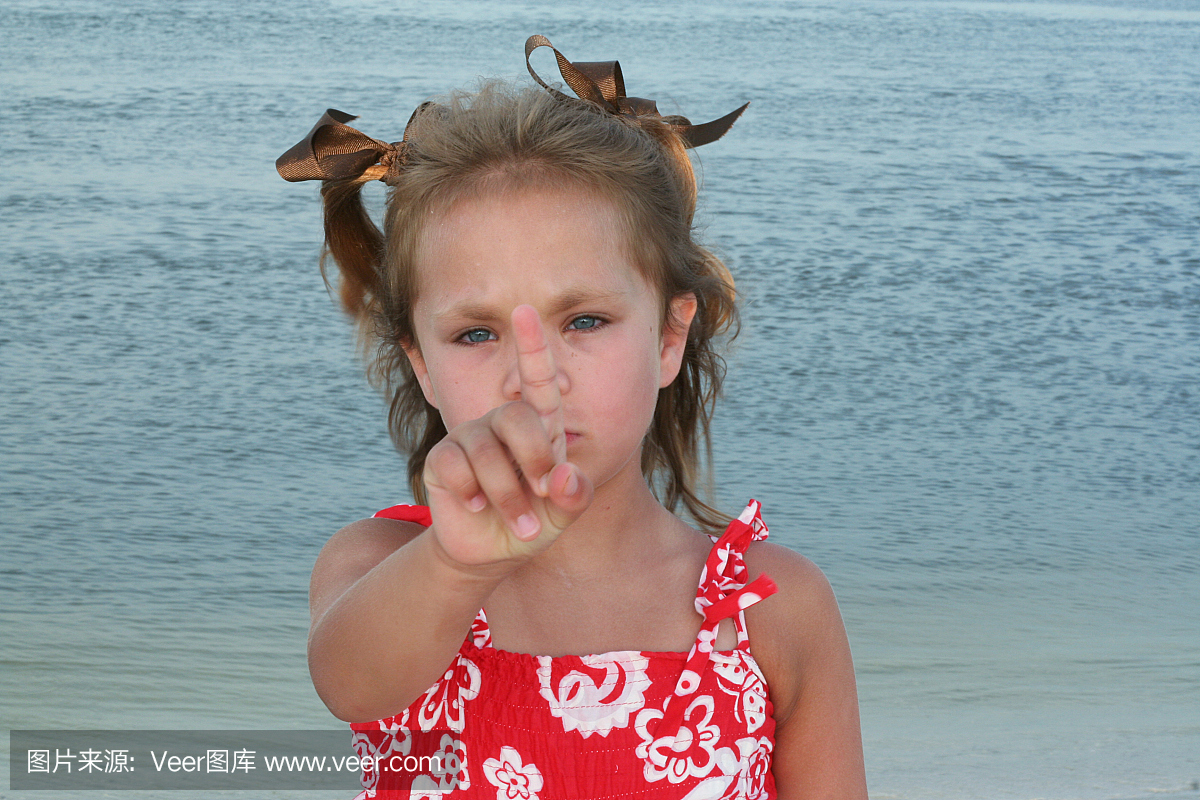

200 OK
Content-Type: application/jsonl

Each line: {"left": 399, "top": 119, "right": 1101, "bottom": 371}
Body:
{"left": 538, "top": 652, "right": 650, "bottom": 739}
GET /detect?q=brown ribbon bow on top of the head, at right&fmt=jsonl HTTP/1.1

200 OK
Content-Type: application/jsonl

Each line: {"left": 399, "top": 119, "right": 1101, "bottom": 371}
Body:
{"left": 526, "top": 34, "right": 750, "bottom": 148}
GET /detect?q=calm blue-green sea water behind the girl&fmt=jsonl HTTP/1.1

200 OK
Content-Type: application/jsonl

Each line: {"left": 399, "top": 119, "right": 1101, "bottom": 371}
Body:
{"left": 0, "top": 0, "right": 1200, "bottom": 800}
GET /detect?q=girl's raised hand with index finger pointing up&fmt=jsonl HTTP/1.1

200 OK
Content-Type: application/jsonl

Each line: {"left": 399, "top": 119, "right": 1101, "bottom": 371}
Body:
{"left": 425, "top": 306, "right": 592, "bottom": 569}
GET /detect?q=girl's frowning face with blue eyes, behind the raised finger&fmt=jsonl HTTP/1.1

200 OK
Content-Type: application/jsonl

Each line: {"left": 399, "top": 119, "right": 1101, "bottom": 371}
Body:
{"left": 408, "top": 188, "right": 696, "bottom": 488}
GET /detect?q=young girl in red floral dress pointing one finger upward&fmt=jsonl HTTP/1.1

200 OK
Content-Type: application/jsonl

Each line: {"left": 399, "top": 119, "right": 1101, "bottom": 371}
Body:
{"left": 278, "top": 36, "right": 866, "bottom": 800}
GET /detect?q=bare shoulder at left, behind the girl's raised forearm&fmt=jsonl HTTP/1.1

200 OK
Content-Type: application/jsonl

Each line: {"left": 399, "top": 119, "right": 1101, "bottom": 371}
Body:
{"left": 308, "top": 517, "right": 425, "bottom": 621}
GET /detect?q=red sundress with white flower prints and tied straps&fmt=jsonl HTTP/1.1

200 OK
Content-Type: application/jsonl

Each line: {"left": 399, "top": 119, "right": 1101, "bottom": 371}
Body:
{"left": 350, "top": 500, "right": 776, "bottom": 800}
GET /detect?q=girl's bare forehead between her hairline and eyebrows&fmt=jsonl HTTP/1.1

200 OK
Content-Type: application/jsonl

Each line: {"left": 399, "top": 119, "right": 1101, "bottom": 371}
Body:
{"left": 415, "top": 187, "right": 656, "bottom": 313}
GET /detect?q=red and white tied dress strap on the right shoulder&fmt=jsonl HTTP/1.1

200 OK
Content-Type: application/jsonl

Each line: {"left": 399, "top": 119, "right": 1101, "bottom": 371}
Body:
{"left": 658, "top": 500, "right": 779, "bottom": 736}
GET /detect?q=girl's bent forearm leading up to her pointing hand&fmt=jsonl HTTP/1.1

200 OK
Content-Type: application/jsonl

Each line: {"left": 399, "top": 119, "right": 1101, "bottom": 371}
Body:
{"left": 308, "top": 530, "right": 504, "bottom": 722}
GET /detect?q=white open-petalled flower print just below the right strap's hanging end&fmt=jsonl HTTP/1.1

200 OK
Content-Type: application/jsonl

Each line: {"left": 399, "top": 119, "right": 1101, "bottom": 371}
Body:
{"left": 634, "top": 694, "right": 721, "bottom": 783}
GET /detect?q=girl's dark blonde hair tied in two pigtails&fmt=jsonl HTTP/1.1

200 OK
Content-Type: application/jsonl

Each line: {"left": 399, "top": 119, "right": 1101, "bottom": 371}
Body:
{"left": 322, "top": 83, "right": 738, "bottom": 529}
